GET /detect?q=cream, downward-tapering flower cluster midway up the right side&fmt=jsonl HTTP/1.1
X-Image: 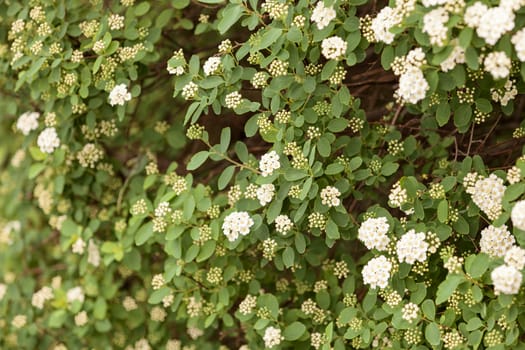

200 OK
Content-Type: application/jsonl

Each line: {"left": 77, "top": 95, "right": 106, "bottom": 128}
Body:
{"left": 466, "top": 174, "right": 507, "bottom": 220}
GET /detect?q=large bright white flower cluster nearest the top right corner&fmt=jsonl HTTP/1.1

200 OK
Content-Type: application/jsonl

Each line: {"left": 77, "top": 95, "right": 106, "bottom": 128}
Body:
{"left": 476, "top": 7, "right": 515, "bottom": 45}
